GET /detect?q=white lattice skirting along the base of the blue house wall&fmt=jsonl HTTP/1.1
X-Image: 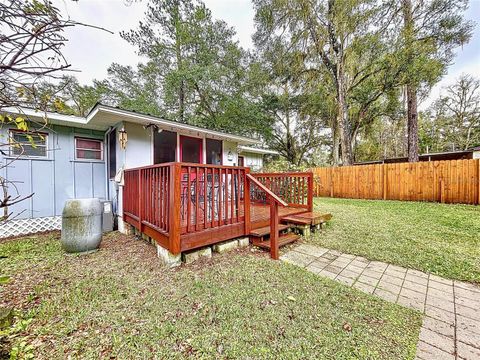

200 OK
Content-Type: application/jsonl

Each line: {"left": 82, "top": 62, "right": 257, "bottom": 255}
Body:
{"left": 0, "top": 216, "right": 62, "bottom": 239}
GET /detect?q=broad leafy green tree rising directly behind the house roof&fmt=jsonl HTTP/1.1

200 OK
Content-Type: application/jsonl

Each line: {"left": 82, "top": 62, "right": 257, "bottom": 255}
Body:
{"left": 122, "top": 0, "right": 270, "bottom": 134}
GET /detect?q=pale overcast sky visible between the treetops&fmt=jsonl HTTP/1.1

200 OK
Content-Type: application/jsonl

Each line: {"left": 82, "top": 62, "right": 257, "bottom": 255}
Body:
{"left": 53, "top": 0, "right": 480, "bottom": 107}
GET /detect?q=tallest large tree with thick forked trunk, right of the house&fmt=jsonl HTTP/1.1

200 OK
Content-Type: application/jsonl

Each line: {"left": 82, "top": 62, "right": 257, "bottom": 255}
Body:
{"left": 254, "top": 0, "right": 402, "bottom": 165}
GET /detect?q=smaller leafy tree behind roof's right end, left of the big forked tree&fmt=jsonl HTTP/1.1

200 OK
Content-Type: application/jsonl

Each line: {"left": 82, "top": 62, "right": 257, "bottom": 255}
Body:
{"left": 256, "top": 39, "right": 329, "bottom": 169}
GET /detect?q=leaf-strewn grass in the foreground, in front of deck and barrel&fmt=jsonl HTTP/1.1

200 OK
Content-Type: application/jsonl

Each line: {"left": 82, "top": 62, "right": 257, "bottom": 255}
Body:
{"left": 0, "top": 232, "right": 421, "bottom": 359}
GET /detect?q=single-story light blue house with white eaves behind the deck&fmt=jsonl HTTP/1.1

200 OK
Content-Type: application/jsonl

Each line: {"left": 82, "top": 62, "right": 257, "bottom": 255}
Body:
{"left": 0, "top": 103, "right": 275, "bottom": 238}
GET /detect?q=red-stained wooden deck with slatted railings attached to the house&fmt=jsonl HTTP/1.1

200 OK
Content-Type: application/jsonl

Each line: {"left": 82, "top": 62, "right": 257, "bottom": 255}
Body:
{"left": 122, "top": 162, "right": 313, "bottom": 258}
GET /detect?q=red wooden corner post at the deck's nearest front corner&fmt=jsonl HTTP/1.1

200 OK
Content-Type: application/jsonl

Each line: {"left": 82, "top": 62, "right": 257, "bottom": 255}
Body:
{"left": 168, "top": 162, "right": 182, "bottom": 255}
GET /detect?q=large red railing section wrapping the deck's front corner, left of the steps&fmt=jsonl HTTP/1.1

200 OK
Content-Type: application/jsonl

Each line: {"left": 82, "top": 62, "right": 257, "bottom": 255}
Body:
{"left": 123, "top": 163, "right": 250, "bottom": 254}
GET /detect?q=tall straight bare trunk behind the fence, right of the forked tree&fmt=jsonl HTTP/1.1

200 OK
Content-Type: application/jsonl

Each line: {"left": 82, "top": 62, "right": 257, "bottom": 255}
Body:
{"left": 402, "top": 0, "right": 418, "bottom": 162}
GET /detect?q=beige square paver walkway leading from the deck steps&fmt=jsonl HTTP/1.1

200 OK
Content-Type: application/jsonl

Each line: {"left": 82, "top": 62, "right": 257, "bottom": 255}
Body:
{"left": 281, "top": 244, "right": 480, "bottom": 360}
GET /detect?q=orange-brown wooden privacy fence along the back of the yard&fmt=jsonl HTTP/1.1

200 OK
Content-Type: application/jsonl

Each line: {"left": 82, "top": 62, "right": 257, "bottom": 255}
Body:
{"left": 313, "top": 159, "right": 480, "bottom": 204}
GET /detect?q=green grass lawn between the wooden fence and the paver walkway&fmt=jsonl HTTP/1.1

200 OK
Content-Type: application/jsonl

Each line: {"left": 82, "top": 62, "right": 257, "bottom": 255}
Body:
{"left": 311, "top": 198, "right": 480, "bottom": 283}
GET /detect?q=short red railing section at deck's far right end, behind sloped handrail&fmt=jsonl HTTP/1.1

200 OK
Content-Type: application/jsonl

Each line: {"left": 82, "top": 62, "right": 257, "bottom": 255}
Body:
{"left": 252, "top": 172, "right": 313, "bottom": 211}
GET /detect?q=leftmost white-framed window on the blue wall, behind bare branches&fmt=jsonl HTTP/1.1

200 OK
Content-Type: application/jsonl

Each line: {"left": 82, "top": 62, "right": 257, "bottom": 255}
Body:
{"left": 10, "top": 130, "right": 47, "bottom": 157}
